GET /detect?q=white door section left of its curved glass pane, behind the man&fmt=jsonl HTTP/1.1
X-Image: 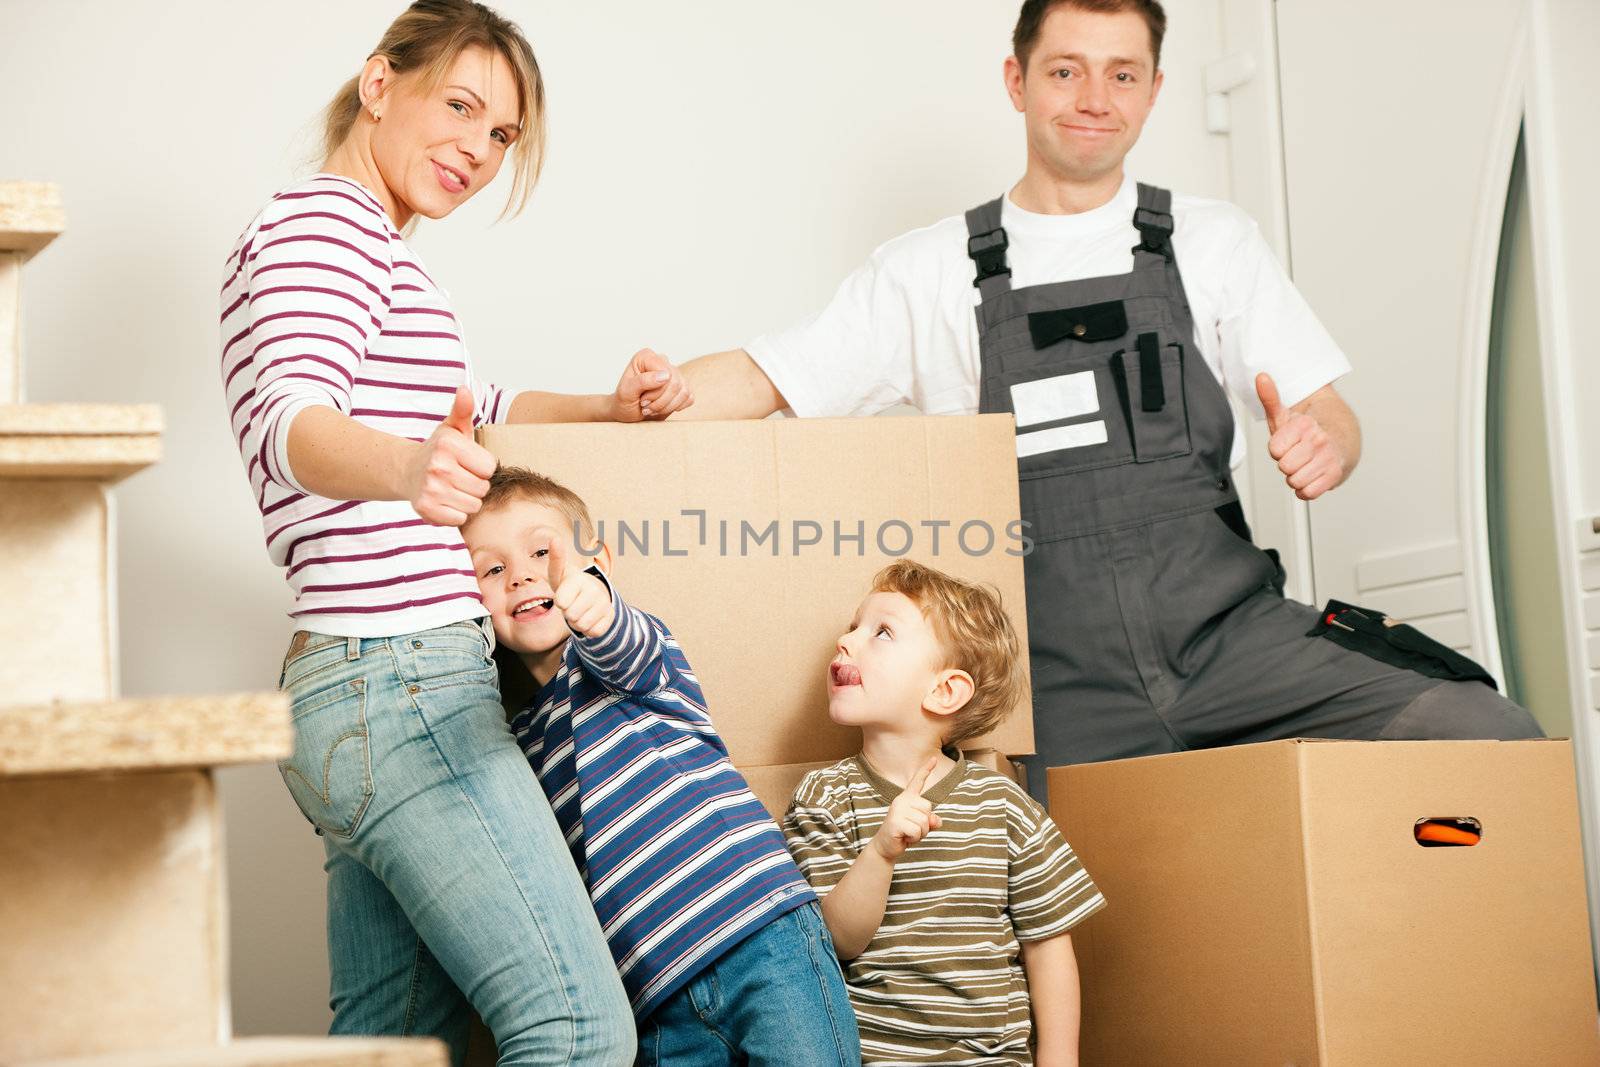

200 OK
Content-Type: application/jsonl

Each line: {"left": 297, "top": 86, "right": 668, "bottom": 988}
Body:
{"left": 1277, "top": 0, "right": 1520, "bottom": 669}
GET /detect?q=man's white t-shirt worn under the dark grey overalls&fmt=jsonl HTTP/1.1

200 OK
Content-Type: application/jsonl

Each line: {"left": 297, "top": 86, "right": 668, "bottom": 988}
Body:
{"left": 744, "top": 178, "right": 1350, "bottom": 467}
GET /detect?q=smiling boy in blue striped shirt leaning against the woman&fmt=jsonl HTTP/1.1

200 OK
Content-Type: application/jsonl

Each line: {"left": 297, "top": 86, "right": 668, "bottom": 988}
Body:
{"left": 461, "top": 467, "right": 861, "bottom": 1067}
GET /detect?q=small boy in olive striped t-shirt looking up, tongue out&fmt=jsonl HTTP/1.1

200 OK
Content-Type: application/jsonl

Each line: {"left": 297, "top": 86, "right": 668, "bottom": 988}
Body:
{"left": 784, "top": 560, "right": 1106, "bottom": 1065}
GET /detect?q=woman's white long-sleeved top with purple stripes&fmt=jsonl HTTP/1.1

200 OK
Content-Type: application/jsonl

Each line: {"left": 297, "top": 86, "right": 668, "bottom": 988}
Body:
{"left": 222, "top": 174, "right": 512, "bottom": 637}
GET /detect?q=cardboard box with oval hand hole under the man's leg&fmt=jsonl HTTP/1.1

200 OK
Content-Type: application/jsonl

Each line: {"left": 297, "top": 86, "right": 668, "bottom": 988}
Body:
{"left": 1050, "top": 741, "right": 1600, "bottom": 1067}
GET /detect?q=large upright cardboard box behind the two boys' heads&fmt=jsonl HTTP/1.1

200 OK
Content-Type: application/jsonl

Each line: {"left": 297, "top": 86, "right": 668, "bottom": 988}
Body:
{"left": 480, "top": 414, "right": 1034, "bottom": 766}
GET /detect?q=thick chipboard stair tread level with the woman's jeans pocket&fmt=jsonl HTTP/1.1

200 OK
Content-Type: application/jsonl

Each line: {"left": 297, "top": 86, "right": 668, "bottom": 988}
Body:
{"left": 0, "top": 693, "right": 293, "bottom": 777}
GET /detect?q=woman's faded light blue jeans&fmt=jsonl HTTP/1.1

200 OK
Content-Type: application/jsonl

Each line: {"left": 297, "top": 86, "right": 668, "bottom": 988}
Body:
{"left": 278, "top": 622, "right": 635, "bottom": 1067}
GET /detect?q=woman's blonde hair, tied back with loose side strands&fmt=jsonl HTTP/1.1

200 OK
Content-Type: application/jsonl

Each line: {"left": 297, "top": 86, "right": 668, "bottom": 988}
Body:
{"left": 322, "top": 0, "right": 546, "bottom": 218}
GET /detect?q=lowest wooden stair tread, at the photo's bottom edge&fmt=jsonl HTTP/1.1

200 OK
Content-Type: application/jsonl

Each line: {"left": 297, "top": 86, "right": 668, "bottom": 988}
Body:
{"left": 18, "top": 1037, "right": 450, "bottom": 1067}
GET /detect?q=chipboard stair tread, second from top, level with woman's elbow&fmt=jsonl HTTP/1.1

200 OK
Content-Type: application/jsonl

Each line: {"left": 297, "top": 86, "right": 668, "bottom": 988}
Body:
{"left": 0, "top": 403, "right": 162, "bottom": 482}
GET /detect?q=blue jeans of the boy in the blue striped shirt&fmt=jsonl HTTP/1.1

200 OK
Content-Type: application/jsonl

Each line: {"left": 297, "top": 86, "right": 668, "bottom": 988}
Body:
{"left": 638, "top": 904, "right": 861, "bottom": 1067}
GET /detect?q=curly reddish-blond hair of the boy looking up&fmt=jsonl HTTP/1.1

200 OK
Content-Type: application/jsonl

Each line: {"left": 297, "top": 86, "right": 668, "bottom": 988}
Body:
{"left": 872, "top": 560, "right": 1022, "bottom": 745}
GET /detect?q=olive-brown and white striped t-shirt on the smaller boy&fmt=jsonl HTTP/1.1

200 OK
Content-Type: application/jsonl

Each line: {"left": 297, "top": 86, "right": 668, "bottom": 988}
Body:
{"left": 784, "top": 755, "right": 1106, "bottom": 1064}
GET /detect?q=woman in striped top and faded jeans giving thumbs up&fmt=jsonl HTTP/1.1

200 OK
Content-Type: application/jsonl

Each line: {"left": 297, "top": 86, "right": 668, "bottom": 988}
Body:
{"left": 222, "top": 0, "right": 690, "bottom": 1064}
